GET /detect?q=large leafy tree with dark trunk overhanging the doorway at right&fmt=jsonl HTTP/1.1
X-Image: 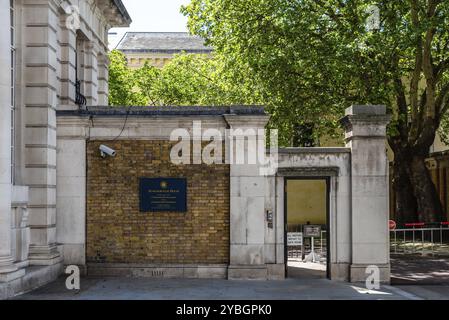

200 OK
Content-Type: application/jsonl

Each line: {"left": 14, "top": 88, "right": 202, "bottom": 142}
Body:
{"left": 182, "top": 0, "right": 449, "bottom": 222}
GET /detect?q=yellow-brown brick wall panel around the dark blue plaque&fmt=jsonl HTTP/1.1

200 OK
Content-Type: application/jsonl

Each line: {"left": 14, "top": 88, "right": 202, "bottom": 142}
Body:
{"left": 86, "top": 140, "right": 230, "bottom": 264}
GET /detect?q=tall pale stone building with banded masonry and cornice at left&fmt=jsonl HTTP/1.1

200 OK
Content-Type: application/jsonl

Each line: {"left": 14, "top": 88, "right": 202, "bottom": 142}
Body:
{"left": 0, "top": 0, "right": 131, "bottom": 297}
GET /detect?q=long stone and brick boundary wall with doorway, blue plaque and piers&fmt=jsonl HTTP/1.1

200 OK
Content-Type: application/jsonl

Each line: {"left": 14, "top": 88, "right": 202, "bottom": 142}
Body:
{"left": 57, "top": 106, "right": 390, "bottom": 282}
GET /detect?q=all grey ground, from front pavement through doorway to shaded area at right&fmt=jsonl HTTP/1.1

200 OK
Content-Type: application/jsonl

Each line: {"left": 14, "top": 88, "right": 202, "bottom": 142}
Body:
{"left": 9, "top": 257, "right": 449, "bottom": 300}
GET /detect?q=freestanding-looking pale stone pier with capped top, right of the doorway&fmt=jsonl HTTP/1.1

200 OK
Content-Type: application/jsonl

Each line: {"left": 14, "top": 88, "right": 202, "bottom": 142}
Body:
{"left": 342, "top": 105, "right": 390, "bottom": 282}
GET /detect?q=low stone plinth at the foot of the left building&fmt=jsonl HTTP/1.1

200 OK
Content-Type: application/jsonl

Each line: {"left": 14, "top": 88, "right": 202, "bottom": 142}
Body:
{"left": 0, "top": 263, "right": 63, "bottom": 300}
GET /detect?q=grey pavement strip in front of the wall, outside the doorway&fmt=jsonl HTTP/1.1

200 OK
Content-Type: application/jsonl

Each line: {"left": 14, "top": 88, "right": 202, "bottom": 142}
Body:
{"left": 15, "top": 277, "right": 418, "bottom": 300}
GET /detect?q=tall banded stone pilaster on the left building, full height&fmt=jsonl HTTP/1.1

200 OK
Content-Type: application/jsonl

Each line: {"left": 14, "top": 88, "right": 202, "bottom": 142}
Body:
{"left": 23, "top": 0, "right": 60, "bottom": 265}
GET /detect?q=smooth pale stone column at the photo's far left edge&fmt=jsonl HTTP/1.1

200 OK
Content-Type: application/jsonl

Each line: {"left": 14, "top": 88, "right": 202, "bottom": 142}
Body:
{"left": 0, "top": 0, "right": 24, "bottom": 282}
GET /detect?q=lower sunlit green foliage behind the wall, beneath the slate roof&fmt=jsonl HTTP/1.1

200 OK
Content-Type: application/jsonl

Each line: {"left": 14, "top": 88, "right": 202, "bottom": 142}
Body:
{"left": 109, "top": 51, "right": 263, "bottom": 106}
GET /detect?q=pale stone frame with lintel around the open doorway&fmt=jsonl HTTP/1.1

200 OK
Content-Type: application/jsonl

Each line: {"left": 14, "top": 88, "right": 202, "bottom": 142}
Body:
{"left": 275, "top": 148, "right": 351, "bottom": 281}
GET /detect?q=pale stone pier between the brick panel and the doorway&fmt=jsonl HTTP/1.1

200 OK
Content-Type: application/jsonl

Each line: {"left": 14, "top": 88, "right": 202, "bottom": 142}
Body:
{"left": 225, "top": 115, "right": 269, "bottom": 279}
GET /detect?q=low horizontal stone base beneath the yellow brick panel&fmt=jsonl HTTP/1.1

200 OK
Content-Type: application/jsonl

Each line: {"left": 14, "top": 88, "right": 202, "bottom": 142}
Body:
{"left": 87, "top": 263, "right": 228, "bottom": 279}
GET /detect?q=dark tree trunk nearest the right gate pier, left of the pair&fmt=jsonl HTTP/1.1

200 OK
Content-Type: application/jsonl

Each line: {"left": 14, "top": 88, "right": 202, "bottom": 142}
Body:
{"left": 393, "top": 156, "right": 418, "bottom": 224}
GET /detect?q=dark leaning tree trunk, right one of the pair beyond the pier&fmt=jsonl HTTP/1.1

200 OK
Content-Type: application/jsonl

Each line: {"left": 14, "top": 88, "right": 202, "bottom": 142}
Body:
{"left": 410, "top": 155, "right": 444, "bottom": 222}
